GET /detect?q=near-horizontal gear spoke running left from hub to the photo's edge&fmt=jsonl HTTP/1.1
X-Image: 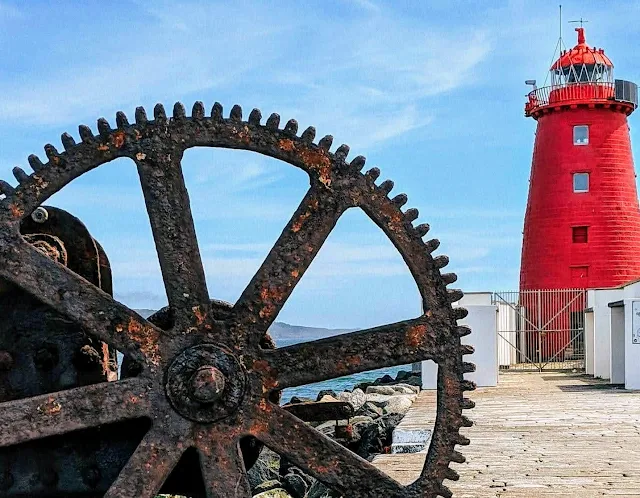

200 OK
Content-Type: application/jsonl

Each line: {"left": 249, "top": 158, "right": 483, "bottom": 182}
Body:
{"left": 0, "top": 378, "right": 151, "bottom": 447}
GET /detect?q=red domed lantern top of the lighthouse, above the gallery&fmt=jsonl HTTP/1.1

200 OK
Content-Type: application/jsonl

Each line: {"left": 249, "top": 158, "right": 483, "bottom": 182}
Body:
{"left": 550, "top": 28, "right": 613, "bottom": 83}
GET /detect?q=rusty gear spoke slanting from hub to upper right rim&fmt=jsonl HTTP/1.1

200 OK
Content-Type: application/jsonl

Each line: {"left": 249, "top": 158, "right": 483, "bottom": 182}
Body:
{"left": 234, "top": 185, "right": 345, "bottom": 341}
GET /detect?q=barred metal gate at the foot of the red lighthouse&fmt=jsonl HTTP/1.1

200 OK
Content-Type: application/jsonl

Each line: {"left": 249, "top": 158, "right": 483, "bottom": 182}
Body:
{"left": 493, "top": 289, "right": 587, "bottom": 372}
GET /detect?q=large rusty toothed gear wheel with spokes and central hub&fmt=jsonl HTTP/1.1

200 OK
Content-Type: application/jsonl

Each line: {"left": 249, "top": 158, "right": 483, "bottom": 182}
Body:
{"left": 0, "top": 102, "right": 474, "bottom": 498}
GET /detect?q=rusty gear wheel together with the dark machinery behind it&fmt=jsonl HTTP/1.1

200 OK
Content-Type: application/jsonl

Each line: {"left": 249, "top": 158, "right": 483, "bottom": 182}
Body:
{"left": 0, "top": 102, "right": 474, "bottom": 498}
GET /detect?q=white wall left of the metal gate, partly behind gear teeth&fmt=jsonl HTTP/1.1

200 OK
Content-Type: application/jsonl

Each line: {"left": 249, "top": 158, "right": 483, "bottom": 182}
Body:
{"left": 422, "top": 293, "right": 498, "bottom": 389}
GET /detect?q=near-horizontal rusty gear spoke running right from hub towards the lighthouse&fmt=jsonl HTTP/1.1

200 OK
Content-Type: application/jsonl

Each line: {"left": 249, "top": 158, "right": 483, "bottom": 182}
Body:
{"left": 262, "top": 315, "right": 439, "bottom": 389}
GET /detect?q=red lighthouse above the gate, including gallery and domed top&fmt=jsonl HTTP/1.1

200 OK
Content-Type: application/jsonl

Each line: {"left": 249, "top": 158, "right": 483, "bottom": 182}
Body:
{"left": 520, "top": 28, "right": 640, "bottom": 290}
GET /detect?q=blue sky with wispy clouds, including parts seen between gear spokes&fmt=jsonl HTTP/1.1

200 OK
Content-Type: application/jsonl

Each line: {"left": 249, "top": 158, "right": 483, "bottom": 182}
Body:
{"left": 0, "top": 0, "right": 640, "bottom": 327}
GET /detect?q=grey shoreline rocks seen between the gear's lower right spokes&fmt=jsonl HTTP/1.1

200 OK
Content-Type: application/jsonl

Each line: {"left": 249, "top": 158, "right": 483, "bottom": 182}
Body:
{"left": 248, "top": 371, "right": 421, "bottom": 498}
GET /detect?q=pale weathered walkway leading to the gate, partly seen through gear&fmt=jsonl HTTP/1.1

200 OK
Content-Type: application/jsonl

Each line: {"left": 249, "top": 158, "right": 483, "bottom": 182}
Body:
{"left": 374, "top": 372, "right": 640, "bottom": 498}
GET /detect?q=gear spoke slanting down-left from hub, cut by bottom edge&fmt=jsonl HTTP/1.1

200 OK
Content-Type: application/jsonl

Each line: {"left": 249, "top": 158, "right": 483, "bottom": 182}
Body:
{"left": 104, "top": 428, "right": 186, "bottom": 498}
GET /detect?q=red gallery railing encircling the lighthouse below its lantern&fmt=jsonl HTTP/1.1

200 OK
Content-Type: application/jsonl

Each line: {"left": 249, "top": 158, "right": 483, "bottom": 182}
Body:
{"left": 525, "top": 80, "right": 638, "bottom": 113}
